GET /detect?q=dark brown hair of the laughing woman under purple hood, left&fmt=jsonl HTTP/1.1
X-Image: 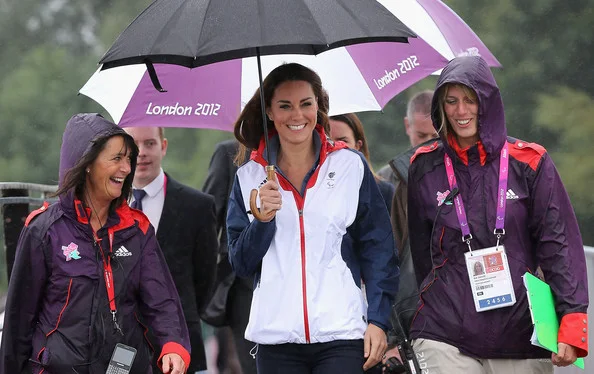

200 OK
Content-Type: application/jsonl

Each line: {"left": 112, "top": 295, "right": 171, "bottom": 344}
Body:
{"left": 52, "top": 133, "right": 138, "bottom": 213}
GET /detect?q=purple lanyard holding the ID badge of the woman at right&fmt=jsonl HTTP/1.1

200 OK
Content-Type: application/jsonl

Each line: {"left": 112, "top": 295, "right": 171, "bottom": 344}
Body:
{"left": 443, "top": 142, "right": 509, "bottom": 252}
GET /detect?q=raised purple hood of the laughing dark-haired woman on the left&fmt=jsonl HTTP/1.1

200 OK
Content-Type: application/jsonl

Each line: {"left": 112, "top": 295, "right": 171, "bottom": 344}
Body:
{"left": 59, "top": 113, "right": 136, "bottom": 206}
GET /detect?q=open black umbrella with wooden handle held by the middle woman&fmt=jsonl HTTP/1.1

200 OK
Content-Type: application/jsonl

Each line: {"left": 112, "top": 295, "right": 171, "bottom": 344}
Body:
{"left": 86, "top": 0, "right": 415, "bottom": 220}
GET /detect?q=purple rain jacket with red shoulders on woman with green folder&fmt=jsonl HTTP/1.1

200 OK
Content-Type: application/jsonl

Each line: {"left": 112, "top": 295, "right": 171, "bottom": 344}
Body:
{"left": 408, "top": 56, "right": 588, "bottom": 359}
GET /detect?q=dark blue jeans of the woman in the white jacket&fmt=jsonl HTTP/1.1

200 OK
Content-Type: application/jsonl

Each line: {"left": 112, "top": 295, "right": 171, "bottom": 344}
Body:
{"left": 256, "top": 340, "right": 365, "bottom": 374}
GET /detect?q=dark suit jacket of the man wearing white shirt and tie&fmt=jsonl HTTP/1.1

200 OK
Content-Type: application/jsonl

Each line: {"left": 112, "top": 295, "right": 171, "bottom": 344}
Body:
{"left": 157, "top": 174, "right": 218, "bottom": 373}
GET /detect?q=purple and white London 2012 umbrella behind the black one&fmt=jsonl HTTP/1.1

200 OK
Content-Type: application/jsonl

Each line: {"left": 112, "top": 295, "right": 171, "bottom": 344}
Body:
{"left": 80, "top": 0, "right": 500, "bottom": 131}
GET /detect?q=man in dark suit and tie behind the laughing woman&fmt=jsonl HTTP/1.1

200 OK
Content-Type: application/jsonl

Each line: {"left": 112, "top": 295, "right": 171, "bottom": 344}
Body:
{"left": 125, "top": 127, "right": 218, "bottom": 374}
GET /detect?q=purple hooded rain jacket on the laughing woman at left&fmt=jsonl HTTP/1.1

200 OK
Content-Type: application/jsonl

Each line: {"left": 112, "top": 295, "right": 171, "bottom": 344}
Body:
{"left": 0, "top": 114, "right": 190, "bottom": 374}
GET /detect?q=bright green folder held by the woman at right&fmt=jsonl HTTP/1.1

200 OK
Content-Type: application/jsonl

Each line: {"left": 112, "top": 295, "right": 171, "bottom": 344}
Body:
{"left": 523, "top": 273, "right": 584, "bottom": 369}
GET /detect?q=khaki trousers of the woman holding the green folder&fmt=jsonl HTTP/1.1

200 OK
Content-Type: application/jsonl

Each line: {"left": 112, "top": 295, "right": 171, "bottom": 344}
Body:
{"left": 413, "top": 338, "right": 553, "bottom": 374}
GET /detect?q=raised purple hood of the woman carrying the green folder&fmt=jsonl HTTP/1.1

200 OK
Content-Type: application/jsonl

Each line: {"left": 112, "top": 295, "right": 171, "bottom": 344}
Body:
{"left": 431, "top": 56, "right": 507, "bottom": 159}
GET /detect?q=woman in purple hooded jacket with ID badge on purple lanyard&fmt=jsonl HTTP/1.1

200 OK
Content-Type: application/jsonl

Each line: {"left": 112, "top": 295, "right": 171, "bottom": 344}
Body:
{"left": 408, "top": 56, "right": 588, "bottom": 374}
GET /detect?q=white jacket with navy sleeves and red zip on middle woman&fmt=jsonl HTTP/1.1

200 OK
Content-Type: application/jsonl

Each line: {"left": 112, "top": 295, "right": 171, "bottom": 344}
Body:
{"left": 227, "top": 126, "right": 399, "bottom": 344}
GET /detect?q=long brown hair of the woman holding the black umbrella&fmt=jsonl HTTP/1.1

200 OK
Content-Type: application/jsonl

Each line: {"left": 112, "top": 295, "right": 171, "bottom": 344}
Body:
{"left": 233, "top": 63, "right": 330, "bottom": 165}
